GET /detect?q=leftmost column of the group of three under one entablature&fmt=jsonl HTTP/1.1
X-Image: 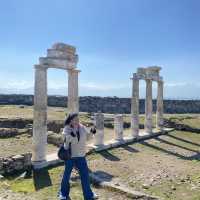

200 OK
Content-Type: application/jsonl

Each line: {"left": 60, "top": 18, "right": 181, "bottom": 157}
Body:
{"left": 131, "top": 73, "right": 139, "bottom": 137}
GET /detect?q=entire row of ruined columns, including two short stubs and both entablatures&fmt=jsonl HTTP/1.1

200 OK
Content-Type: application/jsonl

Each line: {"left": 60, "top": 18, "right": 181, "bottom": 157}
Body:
{"left": 32, "top": 43, "right": 163, "bottom": 168}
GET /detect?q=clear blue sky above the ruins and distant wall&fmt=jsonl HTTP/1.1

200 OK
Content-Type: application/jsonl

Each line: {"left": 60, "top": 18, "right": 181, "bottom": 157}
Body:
{"left": 0, "top": 0, "right": 200, "bottom": 99}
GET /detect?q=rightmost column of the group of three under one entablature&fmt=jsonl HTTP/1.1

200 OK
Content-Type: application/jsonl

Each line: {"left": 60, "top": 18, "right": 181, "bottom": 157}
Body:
{"left": 156, "top": 80, "right": 163, "bottom": 129}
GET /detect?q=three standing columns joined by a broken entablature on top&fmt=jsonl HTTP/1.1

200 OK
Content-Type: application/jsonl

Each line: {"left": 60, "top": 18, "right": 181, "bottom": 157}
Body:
{"left": 131, "top": 66, "right": 163, "bottom": 137}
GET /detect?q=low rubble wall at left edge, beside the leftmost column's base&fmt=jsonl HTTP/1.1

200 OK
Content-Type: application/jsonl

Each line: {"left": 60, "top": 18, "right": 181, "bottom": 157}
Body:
{"left": 0, "top": 153, "right": 32, "bottom": 174}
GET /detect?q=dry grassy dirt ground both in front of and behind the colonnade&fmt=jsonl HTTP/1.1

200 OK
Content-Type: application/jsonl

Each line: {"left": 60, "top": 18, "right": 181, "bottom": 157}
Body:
{"left": 0, "top": 106, "right": 200, "bottom": 200}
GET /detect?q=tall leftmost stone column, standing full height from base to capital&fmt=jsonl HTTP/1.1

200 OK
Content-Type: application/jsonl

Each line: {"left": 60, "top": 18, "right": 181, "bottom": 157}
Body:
{"left": 32, "top": 65, "right": 47, "bottom": 167}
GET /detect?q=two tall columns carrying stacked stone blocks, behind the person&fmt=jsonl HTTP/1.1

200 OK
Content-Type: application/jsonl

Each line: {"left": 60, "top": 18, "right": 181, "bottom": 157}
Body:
{"left": 32, "top": 43, "right": 80, "bottom": 168}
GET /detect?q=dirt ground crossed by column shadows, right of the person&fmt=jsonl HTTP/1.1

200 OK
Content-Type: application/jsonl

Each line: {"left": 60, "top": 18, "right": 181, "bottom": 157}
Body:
{"left": 88, "top": 131, "right": 200, "bottom": 200}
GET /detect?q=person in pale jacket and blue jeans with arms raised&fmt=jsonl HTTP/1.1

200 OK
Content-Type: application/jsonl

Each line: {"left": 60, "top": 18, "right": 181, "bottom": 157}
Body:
{"left": 59, "top": 113, "right": 98, "bottom": 200}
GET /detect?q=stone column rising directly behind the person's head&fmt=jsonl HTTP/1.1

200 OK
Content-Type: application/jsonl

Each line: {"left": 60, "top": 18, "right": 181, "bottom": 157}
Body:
{"left": 68, "top": 69, "right": 80, "bottom": 112}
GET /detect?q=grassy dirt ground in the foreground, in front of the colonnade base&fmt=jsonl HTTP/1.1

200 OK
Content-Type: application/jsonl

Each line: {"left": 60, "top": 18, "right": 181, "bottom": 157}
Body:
{"left": 0, "top": 131, "right": 200, "bottom": 200}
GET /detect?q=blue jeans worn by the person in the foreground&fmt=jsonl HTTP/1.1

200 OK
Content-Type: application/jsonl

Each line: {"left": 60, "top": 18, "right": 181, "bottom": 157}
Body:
{"left": 60, "top": 157, "right": 93, "bottom": 200}
